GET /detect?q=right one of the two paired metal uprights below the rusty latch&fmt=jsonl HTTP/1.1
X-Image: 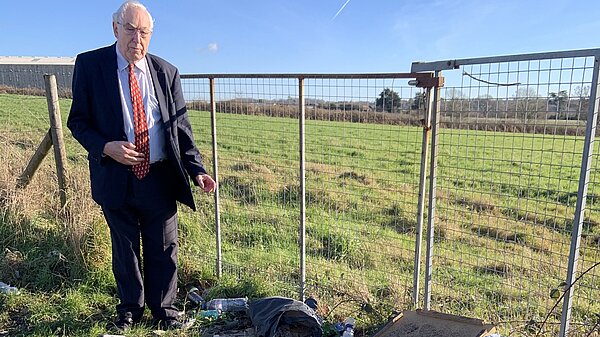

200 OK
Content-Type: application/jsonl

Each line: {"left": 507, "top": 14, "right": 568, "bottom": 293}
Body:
{"left": 423, "top": 70, "right": 442, "bottom": 310}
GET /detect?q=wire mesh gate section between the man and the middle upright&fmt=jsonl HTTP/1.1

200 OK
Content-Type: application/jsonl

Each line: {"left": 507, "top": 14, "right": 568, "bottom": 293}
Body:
{"left": 183, "top": 78, "right": 300, "bottom": 296}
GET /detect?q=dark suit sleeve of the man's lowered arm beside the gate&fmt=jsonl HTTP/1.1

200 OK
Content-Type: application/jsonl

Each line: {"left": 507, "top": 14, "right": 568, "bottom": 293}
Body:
{"left": 171, "top": 65, "right": 207, "bottom": 181}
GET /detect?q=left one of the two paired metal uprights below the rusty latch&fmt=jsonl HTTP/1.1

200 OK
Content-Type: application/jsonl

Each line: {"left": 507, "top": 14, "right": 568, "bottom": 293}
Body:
{"left": 413, "top": 88, "right": 433, "bottom": 308}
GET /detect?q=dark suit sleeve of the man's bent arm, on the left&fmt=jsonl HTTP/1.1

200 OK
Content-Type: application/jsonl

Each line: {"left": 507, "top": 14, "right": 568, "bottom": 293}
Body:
{"left": 67, "top": 55, "right": 106, "bottom": 162}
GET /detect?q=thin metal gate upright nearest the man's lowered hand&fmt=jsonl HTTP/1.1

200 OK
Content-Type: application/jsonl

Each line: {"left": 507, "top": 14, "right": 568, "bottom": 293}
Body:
{"left": 209, "top": 77, "right": 223, "bottom": 277}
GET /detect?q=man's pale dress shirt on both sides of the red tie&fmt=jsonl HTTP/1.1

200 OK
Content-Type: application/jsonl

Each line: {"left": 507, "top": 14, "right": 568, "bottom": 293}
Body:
{"left": 115, "top": 47, "right": 167, "bottom": 164}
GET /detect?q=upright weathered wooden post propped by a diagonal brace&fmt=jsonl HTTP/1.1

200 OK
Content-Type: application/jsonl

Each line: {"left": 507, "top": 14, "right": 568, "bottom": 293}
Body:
{"left": 44, "top": 74, "right": 67, "bottom": 207}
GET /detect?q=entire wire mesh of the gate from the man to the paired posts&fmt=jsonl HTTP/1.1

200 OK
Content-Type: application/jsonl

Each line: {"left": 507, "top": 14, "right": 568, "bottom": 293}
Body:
{"left": 183, "top": 75, "right": 425, "bottom": 323}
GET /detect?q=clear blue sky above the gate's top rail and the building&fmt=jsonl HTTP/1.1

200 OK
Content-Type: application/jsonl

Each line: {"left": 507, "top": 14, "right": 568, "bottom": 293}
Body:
{"left": 0, "top": 0, "right": 600, "bottom": 73}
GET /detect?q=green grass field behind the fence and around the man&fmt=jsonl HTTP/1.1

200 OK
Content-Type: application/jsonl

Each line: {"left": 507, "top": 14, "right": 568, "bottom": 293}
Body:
{"left": 0, "top": 94, "right": 600, "bottom": 336}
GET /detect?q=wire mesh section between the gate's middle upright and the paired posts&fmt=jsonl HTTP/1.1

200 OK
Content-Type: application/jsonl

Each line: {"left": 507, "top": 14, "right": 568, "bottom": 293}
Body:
{"left": 305, "top": 77, "right": 424, "bottom": 326}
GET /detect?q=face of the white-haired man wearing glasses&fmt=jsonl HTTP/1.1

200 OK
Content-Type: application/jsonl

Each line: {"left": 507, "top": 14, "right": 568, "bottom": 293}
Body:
{"left": 113, "top": 7, "right": 152, "bottom": 63}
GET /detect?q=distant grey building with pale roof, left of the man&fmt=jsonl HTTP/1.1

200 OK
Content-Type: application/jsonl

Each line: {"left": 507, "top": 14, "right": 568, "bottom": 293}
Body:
{"left": 0, "top": 56, "right": 75, "bottom": 91}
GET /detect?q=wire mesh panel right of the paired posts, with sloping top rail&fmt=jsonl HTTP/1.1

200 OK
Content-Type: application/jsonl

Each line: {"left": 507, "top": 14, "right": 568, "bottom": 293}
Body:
{"left": 412, "top": 51, "right": 600, "bottom": 335}
